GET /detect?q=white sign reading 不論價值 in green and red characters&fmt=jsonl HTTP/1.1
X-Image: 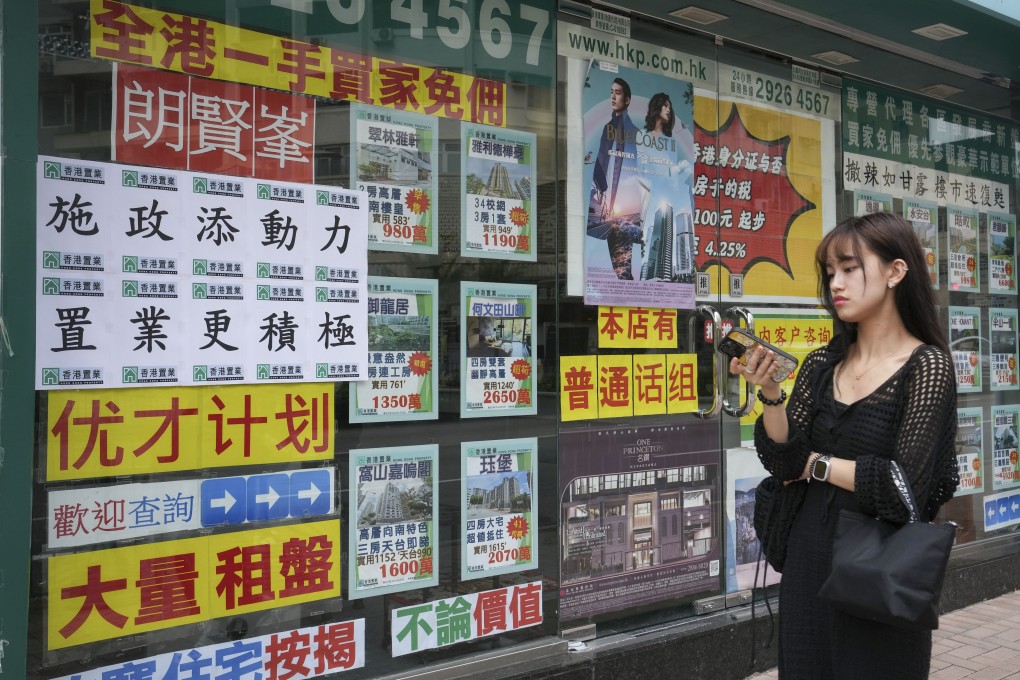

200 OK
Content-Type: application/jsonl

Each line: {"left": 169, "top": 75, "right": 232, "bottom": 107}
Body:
{"left": 390, "top": 581, "right": 542, "bottom": 657}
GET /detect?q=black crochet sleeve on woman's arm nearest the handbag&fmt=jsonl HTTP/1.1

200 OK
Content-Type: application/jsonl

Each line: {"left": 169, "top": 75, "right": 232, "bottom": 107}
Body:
{"left": 854, "top": 347, "right": 959, "bottom": 523}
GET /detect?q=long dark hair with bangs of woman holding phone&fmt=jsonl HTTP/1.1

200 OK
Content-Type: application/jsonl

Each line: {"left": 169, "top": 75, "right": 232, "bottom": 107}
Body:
{"left": 815, "top": 212, "right": 950, "bottom": 355}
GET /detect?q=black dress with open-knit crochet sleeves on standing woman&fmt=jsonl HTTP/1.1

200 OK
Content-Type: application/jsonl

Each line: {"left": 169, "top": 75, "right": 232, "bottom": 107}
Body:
{"left": 755, "top": 337, "right": 959, "bottom": 680}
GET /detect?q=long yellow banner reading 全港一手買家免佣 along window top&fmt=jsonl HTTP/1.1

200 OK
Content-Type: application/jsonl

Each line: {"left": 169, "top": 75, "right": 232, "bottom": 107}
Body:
{"left": 90, "top": 0, "right": 506, "bottom": 127}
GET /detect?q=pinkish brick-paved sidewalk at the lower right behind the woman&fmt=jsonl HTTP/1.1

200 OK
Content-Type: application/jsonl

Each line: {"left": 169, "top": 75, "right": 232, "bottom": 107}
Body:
{"left": 750, "top": 590, "right": 1020, "bottom": 680}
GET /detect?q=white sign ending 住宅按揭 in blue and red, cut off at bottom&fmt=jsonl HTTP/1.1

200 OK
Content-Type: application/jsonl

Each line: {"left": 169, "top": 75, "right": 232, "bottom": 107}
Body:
{"left": 53, "top": 619, "right": 365, "bottom": 680}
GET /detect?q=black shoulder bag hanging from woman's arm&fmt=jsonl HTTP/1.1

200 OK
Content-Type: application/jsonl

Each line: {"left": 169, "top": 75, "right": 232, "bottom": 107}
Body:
{"left": 818, "top": 461, "right": 956, "bottom": 630}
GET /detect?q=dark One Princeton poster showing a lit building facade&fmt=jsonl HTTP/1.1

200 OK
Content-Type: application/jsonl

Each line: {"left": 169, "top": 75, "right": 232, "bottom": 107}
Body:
{"left": 560, "top": 421, "right": 723, "bottom": 621}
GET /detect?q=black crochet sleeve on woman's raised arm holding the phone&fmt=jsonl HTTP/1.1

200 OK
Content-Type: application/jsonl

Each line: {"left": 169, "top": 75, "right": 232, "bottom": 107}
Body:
{"left": 755, "top": 348, "right": 827, "bottom": 480}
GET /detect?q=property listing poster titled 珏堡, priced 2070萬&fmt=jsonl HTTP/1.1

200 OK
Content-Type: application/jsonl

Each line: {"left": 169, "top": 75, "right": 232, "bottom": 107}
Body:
{"left": 460, "top": 437, "right": 539, "bottom": 581}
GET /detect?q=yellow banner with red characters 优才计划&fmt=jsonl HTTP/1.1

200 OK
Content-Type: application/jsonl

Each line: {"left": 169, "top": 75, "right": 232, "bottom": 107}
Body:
{"left": 46, "top": 382, "right": 334, "bottom": 481}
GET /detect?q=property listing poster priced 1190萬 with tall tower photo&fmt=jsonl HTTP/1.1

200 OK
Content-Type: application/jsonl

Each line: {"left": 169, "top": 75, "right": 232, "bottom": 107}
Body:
{"left": 460, "top": 123, "right": 538, "bottom": 262}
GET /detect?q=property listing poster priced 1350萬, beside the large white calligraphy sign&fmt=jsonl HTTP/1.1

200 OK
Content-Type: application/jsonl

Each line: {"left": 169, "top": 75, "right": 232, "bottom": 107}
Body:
{"left": 350, "top": 276, "right": 439, "bottom": 423}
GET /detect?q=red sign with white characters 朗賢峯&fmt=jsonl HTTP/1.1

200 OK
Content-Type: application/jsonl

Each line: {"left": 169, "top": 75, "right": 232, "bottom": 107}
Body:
{"left": 113, "top": 64, "right": 315, "bottom": 184}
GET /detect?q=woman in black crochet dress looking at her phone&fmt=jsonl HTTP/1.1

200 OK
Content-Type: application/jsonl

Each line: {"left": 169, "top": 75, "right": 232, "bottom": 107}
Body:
{"left": 729, "top": 213, "right": 959, "bottom": 680}
